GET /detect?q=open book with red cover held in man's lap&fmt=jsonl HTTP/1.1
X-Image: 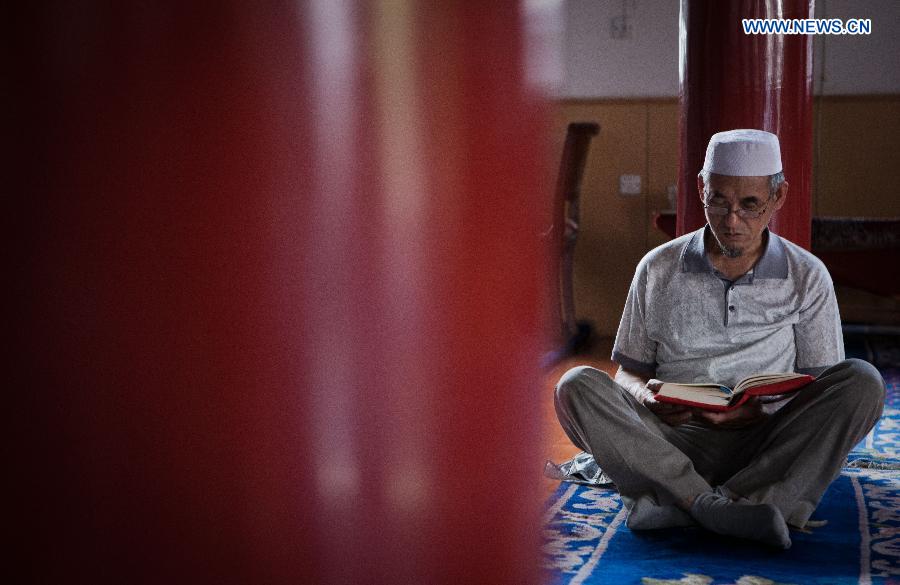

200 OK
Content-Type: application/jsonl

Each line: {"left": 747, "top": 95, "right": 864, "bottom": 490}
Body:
{"left": 656, "top": 374, "right": 815, "bottom": 411}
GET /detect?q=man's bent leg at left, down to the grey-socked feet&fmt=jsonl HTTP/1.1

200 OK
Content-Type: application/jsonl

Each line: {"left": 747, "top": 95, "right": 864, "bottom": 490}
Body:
{"left": 556, "top": 367, "right": 791, "bottom": 548}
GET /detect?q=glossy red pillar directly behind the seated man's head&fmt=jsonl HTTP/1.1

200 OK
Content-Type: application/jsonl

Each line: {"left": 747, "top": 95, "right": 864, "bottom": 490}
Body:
{"left": 676, "top": 0, "right": 814, "bottom": 249}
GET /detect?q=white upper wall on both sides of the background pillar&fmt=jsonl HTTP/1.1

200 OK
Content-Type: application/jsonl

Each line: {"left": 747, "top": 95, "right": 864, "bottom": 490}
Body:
{"left": 559, "top": 0, "right": 900, "bottom": 98}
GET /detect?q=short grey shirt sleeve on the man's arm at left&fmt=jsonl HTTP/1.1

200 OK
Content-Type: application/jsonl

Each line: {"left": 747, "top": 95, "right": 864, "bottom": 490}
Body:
{"left": 612, "top": 261, "right": 656, "bottom": 377}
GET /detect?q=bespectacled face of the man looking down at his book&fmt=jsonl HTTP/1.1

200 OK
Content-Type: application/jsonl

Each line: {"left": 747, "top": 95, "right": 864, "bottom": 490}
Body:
{"left": 698, "top": 174, "right": 787, "bottom": 258}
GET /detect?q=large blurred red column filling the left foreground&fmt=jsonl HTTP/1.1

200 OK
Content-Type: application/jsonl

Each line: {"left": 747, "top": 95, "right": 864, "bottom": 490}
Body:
{"left": 12, "top": 0, "right": 551, "bottom": 584}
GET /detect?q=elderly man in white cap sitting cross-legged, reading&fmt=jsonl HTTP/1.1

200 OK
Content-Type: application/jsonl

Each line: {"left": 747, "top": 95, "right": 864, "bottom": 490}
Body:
{"left": 556, "top": 130, "right": 884, "bottom": 548}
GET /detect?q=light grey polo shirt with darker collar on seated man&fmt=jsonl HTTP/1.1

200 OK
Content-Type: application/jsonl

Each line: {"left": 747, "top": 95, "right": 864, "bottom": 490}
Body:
{"left": 612, "top": 227, "right": 844, "bottom": 386}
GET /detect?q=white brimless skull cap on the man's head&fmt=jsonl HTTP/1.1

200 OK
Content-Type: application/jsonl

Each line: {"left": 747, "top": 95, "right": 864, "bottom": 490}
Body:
{"left": 703, "top": 130, "right": 782, "bottom": 177}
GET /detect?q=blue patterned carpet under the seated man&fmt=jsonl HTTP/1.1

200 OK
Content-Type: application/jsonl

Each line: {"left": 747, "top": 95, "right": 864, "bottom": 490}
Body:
{"left": 544, "top": 368, "right": 900, "bottom": 585}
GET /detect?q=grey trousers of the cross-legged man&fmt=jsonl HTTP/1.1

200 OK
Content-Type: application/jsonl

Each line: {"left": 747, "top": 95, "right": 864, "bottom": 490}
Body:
{"left": 556, "top": 359, "right": 884, "bottom": 528}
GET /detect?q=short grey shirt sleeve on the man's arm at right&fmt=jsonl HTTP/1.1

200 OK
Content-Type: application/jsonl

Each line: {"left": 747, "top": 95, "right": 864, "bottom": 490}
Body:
{"left": 794, "top": 266, "right": 844, "bottom": 375}
